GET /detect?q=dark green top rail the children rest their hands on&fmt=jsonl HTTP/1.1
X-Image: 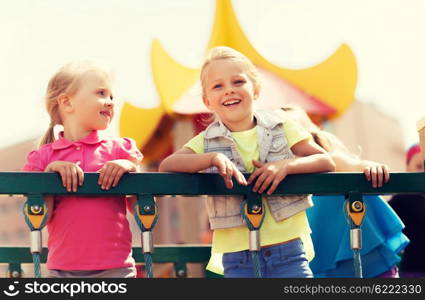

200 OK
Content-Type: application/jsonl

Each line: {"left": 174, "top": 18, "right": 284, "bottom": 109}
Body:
{"left": 0, "top": 172, "right": 425, "bottom": 196}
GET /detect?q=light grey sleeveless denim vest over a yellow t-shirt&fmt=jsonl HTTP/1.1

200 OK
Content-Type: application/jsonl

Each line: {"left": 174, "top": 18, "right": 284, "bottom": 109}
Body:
{"left": 204, "top": 110, "right": 313, "bottom": 229}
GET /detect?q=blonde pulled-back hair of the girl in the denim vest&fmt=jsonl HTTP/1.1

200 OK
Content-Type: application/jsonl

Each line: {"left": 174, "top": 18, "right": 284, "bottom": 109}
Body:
{"left": 200, "top": 46, "right": 261, "bottom": 95}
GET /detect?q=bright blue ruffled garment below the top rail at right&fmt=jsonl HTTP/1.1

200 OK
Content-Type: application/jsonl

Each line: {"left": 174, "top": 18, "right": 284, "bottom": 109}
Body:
{"left": 307, "top": 195, "right": 409, "bottom": 278}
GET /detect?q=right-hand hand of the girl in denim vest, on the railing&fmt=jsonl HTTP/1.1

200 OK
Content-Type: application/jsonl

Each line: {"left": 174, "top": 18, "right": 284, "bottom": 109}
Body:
{"left": 248, "top": 160, "right": 289, "bottom": 195}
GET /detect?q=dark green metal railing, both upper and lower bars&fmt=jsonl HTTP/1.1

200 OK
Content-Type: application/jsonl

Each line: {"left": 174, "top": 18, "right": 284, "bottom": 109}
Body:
{"left": 0, "top": 172, "right": 425, "bottom": 275}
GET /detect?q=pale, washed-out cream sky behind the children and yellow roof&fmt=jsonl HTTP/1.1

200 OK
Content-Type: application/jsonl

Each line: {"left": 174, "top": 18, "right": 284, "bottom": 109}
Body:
{"left": 0, "top": 0, "right": 425, "bottom": 147}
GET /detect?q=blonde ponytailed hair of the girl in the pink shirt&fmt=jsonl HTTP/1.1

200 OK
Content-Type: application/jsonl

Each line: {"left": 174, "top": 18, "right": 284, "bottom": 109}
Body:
{"left": 39, "top": 60, "right": 111, "bottom": 147}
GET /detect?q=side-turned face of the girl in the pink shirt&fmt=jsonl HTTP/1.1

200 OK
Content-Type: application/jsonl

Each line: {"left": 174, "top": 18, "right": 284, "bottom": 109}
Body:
{"left": 69, "top": 71, "right": 114, "bottom": 131}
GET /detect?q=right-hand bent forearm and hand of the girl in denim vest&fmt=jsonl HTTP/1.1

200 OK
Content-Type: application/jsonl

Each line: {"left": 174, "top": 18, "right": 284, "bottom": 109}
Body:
{"left": 248, "top": 139, "right": 335, "bottom": 195}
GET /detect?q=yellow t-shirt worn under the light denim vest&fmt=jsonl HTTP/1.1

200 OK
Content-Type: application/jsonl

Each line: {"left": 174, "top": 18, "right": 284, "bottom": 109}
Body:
{"left": 184, "top": 120, "right": 314, "bottom": 274}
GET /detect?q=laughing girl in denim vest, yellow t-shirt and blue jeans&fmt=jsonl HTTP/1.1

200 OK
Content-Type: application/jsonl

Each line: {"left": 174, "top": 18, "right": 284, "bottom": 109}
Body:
{"left": 159, "top": 47, "right": 335, "bottom": 277}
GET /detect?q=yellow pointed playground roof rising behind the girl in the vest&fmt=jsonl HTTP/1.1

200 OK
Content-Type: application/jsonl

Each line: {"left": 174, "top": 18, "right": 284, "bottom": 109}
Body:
{"left": 120, "top": 0, "right": 357, "bottom": 148}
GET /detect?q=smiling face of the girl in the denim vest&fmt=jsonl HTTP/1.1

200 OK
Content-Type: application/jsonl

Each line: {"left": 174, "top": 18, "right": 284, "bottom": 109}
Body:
{"left": 202, "top": 59, "right": 258, "bottom": 131}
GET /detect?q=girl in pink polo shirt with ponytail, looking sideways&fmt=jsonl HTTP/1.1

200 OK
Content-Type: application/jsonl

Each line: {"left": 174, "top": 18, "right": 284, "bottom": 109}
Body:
{"left": 23, "top": 62, "right": 143, "bottom": 277}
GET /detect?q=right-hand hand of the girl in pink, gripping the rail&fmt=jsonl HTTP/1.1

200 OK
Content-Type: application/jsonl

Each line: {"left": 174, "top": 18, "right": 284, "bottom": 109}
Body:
{"left": 97, "top": 159, "right": 137, "bottom": 190}
